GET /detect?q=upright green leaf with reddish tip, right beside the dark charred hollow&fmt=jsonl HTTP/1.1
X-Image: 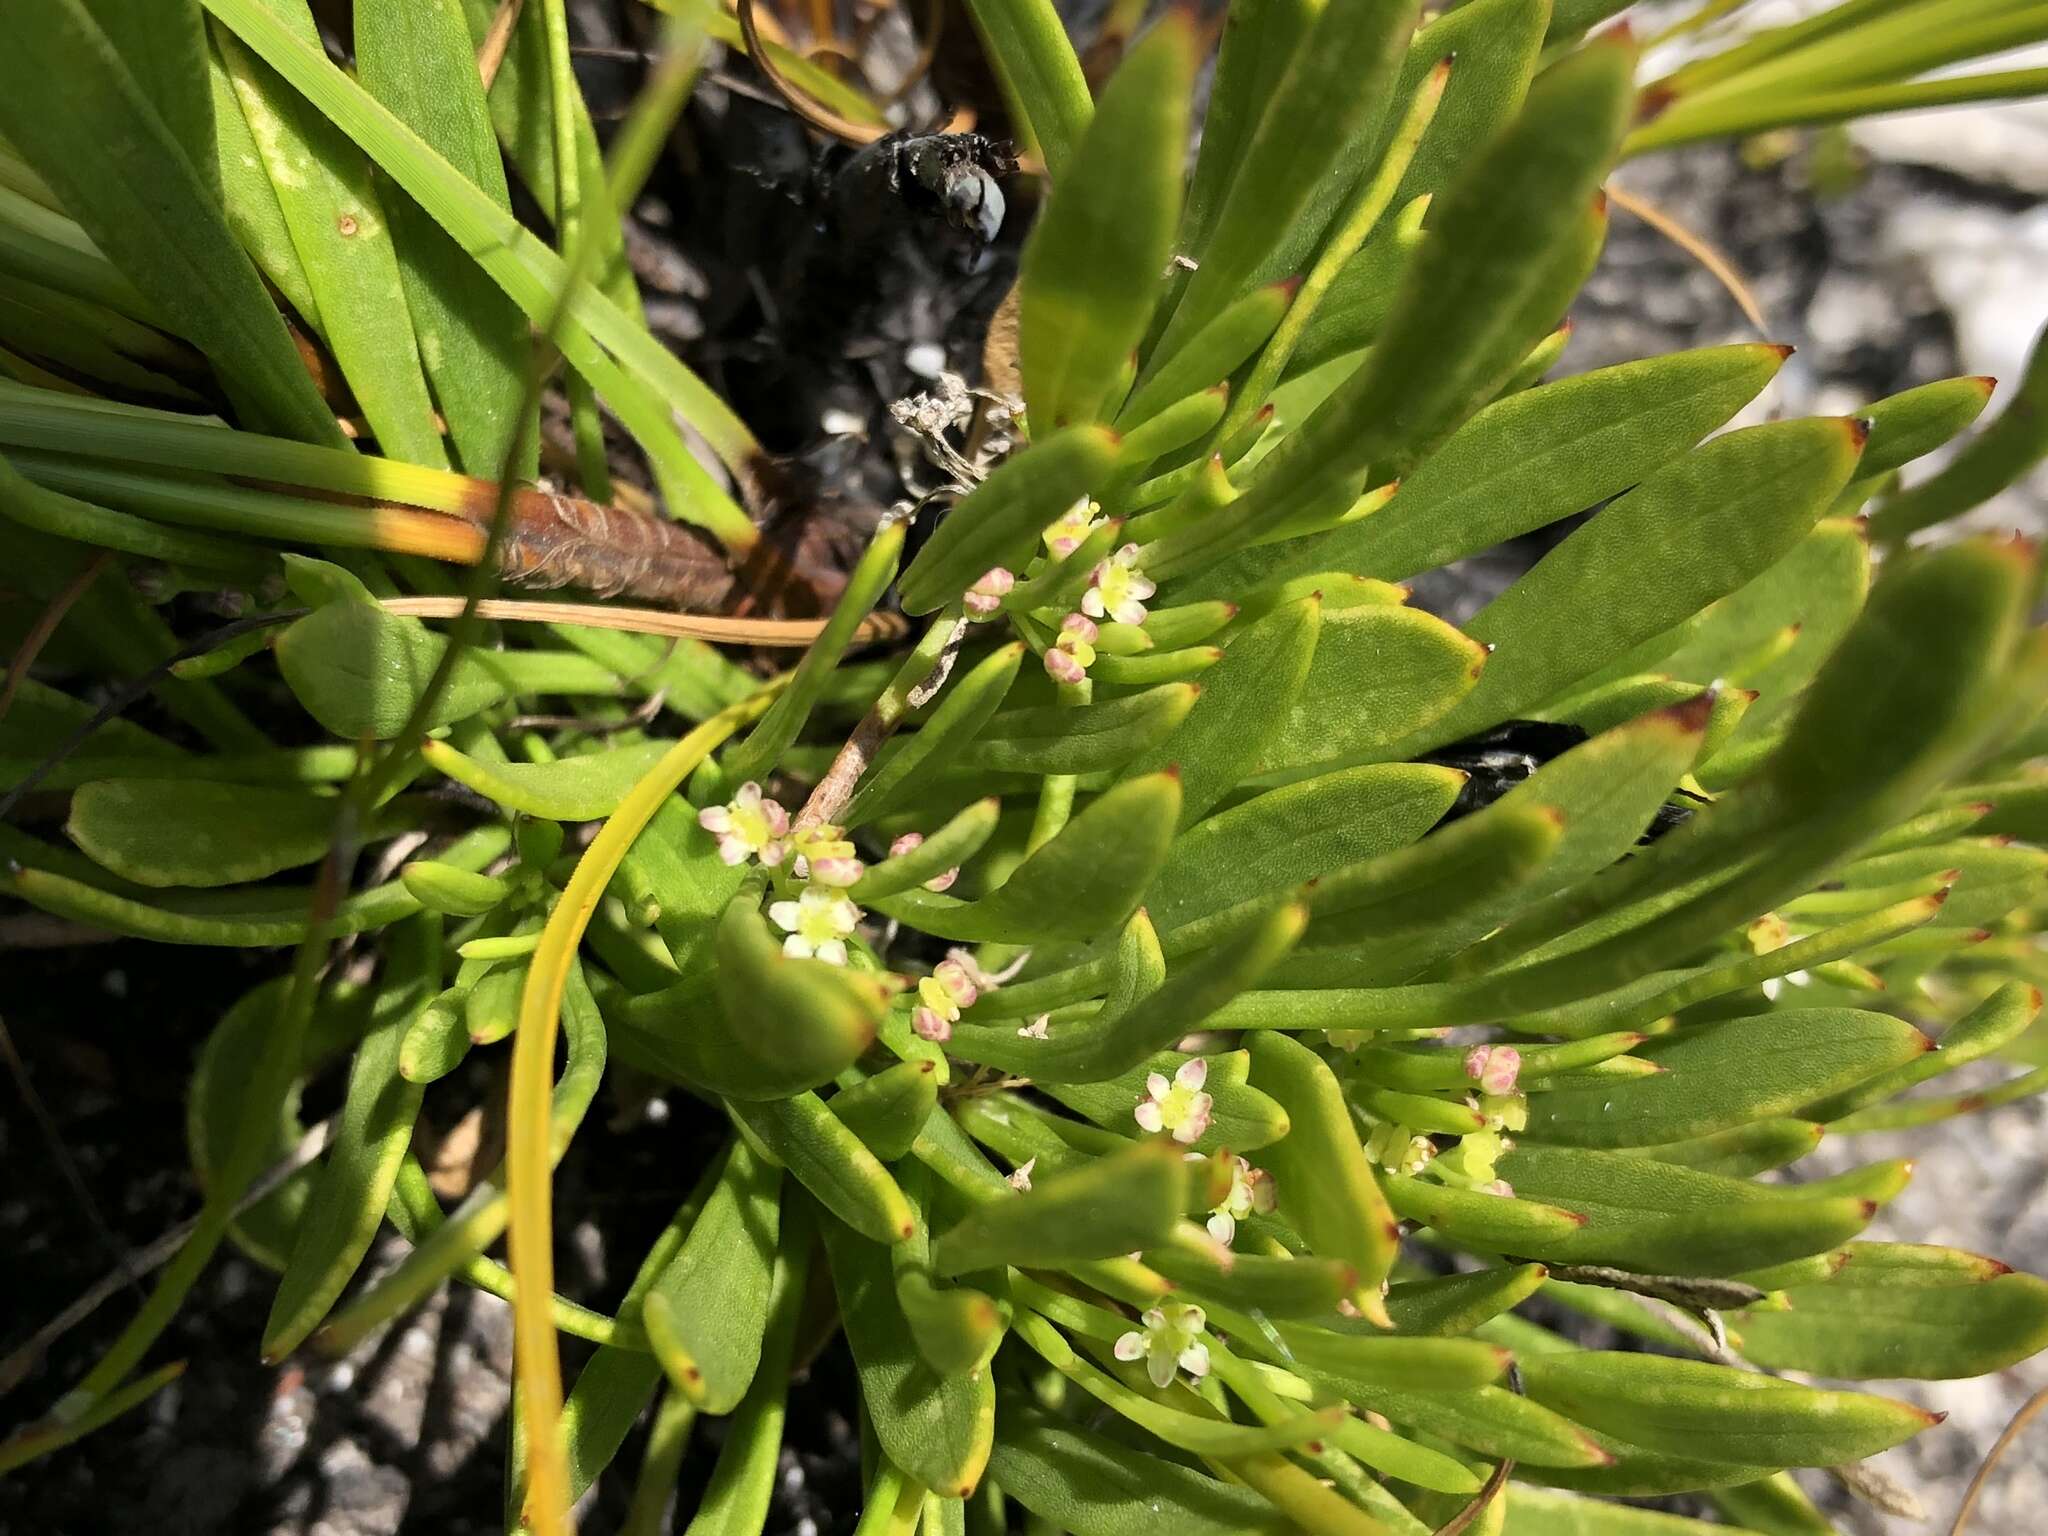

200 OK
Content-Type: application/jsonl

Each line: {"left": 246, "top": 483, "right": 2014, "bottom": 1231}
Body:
{"left": 1018, "top": 12, "right": 1196, "bottom": 436}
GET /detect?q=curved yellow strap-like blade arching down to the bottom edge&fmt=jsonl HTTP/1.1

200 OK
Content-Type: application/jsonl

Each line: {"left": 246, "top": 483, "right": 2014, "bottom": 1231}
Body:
{"left": 506, "top": 680, "right": 782, "bottom": 1536}
